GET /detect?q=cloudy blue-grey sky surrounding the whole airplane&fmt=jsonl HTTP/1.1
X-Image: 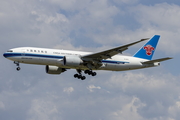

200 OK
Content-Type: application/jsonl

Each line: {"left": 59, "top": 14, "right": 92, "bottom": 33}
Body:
{"left": 0, "top": 0, "right": 180, "bottom": 120}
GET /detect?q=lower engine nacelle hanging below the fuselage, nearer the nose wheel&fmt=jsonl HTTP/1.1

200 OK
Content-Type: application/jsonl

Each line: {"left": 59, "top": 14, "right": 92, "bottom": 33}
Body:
{"left": 46, "top": 65, "right": 64, "bottom": 74}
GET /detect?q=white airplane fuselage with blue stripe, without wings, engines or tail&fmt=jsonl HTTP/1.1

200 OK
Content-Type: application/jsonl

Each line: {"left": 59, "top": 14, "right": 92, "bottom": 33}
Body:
{"left": 4, "top": 47, "right": 158, "bottom": 71}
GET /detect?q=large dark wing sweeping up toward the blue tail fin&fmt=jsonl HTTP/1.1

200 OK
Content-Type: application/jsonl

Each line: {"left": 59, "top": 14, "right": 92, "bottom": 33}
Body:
{"left": 82, "top": 38, "right": 149, "bottom": 60}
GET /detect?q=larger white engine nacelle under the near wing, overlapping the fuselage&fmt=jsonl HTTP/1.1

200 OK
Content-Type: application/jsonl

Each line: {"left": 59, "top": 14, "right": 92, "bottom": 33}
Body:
{"left": 64, "top": 56, "right": 83, "bottom": 67}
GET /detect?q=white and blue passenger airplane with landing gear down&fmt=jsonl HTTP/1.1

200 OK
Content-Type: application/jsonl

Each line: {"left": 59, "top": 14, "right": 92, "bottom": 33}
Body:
{"left": 3, "top": 35, "right": 172, "bottom": 80}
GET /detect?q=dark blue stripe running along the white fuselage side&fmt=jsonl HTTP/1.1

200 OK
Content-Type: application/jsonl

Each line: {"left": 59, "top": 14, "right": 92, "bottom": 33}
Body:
{"left": 3, "top": 53, "right": 129, "bottom": 64}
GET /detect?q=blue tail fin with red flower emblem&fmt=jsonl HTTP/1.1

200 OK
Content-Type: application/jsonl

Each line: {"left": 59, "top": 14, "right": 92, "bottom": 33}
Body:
{"left": 134, "top": 35, "right": 160, "bottom": 60}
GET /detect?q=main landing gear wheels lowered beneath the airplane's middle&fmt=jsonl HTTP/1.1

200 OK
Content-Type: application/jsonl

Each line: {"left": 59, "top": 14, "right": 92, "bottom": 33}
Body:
{"left": 74, "top": 69, "right": 96, "bottom": 80}
